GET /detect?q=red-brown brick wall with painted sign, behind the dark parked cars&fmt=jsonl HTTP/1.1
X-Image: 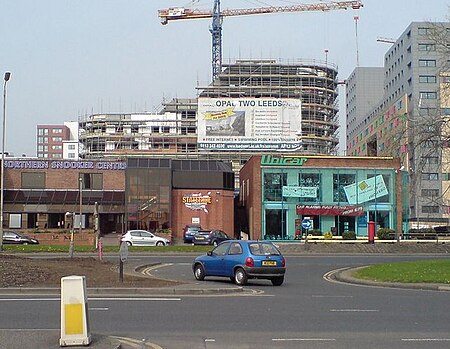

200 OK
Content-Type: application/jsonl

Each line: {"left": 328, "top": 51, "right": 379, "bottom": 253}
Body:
{"left": 171, "top": 189, "right": 234, "bottom": 242}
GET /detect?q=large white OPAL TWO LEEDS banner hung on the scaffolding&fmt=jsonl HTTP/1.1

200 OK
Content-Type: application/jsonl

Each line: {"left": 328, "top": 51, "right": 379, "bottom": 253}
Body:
{"left": 197, "top": 98, "right": 301, "bottom": 151}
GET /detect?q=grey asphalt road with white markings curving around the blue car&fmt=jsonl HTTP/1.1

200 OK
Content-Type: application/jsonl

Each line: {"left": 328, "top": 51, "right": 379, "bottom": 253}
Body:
{"left": 0, "top": 255, "right": 450, "bottom": 349}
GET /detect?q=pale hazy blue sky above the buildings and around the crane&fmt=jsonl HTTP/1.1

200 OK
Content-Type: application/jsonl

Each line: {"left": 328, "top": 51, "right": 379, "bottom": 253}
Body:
{"left": 0, "top": 0, "right": 450, "bottom": 156}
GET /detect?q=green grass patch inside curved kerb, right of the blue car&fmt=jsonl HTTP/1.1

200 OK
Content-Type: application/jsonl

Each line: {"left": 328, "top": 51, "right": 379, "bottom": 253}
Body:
{"left": 353, "top": 259, "right": 450, "bottom": 284}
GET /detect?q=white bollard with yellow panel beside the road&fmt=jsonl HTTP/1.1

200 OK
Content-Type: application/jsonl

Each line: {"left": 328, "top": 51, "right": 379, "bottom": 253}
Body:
{"left": 59, "top": 275, "right": 91, "bottom": 347}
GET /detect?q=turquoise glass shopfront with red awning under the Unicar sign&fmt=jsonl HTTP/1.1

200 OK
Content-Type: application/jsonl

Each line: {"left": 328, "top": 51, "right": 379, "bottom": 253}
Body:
{"left": 261, "top": 167, "right": 397, "bottom": 240}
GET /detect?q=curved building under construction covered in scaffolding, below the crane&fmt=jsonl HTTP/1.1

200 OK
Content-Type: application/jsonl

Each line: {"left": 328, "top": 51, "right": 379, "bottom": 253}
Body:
{"left": 79, "top": 60, "right": 338, "bottom": 181}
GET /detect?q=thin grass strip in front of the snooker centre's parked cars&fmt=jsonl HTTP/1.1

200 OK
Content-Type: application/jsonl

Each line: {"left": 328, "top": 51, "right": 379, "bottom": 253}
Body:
{"left": 3, "top": 244, "right": 213, "bottom": 253}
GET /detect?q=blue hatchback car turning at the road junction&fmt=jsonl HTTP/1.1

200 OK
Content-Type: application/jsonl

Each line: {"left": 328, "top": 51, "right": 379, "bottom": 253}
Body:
{"left": 192, "top": 240, "right": 286, "bottom": 286}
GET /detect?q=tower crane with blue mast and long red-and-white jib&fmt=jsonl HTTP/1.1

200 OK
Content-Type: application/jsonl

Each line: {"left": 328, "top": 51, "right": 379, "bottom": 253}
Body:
{"left": 158, "top": 0, "right": 363, "bottom": 80}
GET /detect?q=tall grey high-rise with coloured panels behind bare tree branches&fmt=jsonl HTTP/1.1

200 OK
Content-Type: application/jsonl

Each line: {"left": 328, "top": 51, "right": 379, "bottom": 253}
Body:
{"left": 347, "top": 22, "right": 450, "bottom": 230}
